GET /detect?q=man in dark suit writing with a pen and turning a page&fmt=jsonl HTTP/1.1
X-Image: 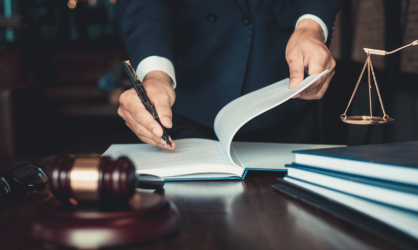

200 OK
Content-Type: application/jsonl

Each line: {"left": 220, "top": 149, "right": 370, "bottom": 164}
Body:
{"left": 117, "top": 0, "right": 341, "bottom": 149}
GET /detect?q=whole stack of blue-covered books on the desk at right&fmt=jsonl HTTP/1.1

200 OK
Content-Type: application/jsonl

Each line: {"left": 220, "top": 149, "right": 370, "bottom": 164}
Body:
{"left": 284, "top": 142, "right": 418, "bottom": 238}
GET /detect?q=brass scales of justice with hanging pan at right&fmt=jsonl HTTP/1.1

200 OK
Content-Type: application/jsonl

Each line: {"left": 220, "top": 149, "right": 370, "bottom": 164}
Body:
{"left": 341, "top": 40, "right": 418, "bottom": 125}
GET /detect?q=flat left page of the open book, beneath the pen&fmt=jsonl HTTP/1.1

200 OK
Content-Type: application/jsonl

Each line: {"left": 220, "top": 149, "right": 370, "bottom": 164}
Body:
{"left": 103, "top": 139, "right": 233, "bottom": 170}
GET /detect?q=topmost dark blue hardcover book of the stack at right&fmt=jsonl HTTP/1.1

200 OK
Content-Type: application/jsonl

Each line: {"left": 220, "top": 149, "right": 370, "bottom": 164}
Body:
{"left": 293, "top": 141, "right": 418, "bottom": 186}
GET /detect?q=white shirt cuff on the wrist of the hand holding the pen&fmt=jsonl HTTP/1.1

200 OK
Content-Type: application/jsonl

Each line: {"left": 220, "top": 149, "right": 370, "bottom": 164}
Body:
{"left": 136, "top": 56, "right": 177, "bottom": 89}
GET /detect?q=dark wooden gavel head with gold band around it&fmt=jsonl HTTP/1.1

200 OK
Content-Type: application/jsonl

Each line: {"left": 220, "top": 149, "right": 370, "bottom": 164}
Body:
{"left": 49, "top": 156, "right": 136, "bottom": 202}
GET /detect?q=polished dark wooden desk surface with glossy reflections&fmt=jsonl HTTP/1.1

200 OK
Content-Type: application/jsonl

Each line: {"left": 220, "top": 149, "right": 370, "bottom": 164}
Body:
{"left": 0, "top": 157, "right": 396, "bottom": 250}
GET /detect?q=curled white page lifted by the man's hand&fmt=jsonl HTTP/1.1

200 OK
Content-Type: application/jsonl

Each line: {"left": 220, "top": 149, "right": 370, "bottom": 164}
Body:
{"left": 214, "top": 70, "right": 329, "bottom": 166}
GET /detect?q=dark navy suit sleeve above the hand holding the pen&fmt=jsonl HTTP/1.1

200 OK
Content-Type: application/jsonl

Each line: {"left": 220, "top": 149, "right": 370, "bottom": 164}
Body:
{"left": 117, "top": 0, "right": 175, "bottom": 78}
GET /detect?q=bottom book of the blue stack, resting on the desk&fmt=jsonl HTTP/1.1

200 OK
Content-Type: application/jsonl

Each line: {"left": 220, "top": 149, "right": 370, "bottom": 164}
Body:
{"left": 273, "top": 177, "right": 418, "bottom": 246}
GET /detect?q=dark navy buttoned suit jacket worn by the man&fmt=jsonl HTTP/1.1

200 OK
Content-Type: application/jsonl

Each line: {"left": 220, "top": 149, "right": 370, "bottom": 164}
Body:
{"left": 117, "top": 0, "right": 341, "bottom": 131}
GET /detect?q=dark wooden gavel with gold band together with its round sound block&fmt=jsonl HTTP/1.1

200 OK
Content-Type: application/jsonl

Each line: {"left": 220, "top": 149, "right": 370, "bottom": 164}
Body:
{"left": 29, "top": 156, "right": 180, "bottom": 249}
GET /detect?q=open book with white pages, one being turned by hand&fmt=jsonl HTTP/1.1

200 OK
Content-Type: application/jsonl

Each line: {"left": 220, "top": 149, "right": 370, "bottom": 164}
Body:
{"left": 103, "top": 70, "right": 338, "bottom": 181}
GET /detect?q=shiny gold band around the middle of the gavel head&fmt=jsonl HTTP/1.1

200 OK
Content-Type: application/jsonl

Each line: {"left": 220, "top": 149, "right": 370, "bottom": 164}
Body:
{"left": 70, "top": 158, "right": 100, "bottom": 201}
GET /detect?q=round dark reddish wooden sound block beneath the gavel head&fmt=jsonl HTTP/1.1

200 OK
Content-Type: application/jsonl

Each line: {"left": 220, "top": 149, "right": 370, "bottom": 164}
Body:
{"left": 30, "top": 192, "right": 180, "bottom": 249}
